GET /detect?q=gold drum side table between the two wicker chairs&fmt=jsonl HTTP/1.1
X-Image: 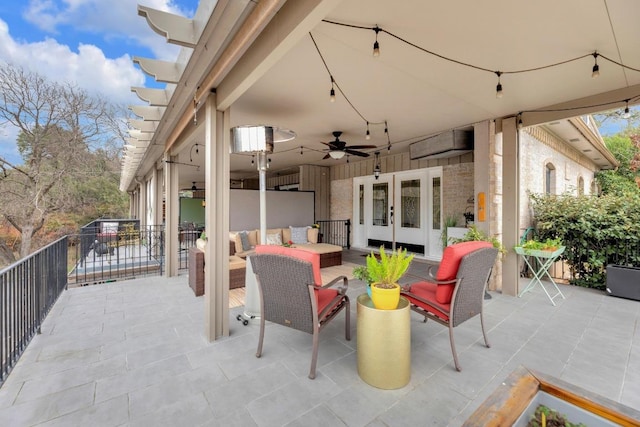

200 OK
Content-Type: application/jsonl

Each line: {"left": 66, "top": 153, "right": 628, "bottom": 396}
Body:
{"left": 356, "top": 294, "right": 411, "bottom": 390}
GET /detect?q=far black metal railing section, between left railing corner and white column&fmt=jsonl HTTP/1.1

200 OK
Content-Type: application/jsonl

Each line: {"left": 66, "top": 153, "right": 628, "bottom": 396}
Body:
{"left": 68, "top": 224, "right": 165, "bottom": 287}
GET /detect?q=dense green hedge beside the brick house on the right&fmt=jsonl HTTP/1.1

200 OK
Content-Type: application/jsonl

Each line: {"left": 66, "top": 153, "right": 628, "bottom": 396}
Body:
{"left": 530, "top": 194, "right": 640, "bottom": 289}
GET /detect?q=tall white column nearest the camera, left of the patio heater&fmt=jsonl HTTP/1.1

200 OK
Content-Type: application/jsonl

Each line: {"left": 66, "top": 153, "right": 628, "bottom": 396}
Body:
{"left": 204, "top": 94, "right": 231, "bottom": 341}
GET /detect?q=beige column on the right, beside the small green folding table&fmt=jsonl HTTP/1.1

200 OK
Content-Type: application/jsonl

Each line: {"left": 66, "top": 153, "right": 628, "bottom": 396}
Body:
{"left": 502, "top": 117, "right": 520, "bottom": 296}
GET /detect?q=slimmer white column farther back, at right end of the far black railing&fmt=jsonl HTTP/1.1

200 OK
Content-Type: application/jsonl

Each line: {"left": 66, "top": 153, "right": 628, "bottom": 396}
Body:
{"left": 164, "top": 153, "right": 180, "bottom": 277}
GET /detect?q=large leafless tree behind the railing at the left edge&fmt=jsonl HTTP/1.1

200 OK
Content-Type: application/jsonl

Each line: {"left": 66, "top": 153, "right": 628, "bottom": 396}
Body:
{"left": 0, "top": 65, "right": 126, "bottom": 257}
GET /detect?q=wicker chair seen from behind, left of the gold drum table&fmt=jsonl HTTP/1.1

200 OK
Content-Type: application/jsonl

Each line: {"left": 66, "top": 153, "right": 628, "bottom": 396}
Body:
{"left": 250, "top": 254, "right": 351, "bottom": 379}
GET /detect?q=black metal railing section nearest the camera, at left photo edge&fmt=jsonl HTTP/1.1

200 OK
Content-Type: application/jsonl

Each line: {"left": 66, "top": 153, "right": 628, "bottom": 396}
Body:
{"left": 0, "top": 237, "right": 68, "bottom": 385}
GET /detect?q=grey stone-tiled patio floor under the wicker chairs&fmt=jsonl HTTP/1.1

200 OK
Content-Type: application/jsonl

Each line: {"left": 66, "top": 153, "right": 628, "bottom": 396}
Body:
{"left": 0, "top": 251, "right": 640, "bottom": 426}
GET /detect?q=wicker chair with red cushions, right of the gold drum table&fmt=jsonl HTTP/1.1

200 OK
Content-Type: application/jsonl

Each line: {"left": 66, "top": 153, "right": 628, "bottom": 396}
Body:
{"left": 401, "top": 241, "right": 498, "bottom": 371}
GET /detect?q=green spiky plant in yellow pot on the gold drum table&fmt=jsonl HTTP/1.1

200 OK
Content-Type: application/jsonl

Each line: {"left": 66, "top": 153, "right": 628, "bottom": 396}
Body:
{"left": 367, "top": 246, "right": 414, "bottom": 310}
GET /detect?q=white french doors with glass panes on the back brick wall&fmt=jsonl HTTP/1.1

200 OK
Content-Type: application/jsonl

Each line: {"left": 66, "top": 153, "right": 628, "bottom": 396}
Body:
{"left": 353, "top": 167, "right": 442, "bottom": 259}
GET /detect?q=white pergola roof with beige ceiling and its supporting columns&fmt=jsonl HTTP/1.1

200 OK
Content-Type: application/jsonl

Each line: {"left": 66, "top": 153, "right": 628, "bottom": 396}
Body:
{"left": 121, "top": 0, "right": 640, "bottom": 339}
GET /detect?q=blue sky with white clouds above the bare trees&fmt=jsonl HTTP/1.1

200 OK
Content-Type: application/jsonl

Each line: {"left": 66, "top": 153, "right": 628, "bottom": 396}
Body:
{"left": 0, "top": 0, "right": 198, "bottom": 161}
